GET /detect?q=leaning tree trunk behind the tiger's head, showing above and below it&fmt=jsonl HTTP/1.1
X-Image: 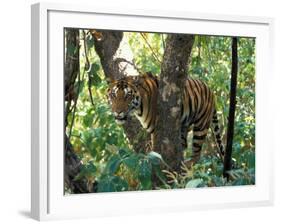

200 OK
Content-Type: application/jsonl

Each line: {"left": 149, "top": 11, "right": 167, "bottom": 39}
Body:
{"left": 93, "top": 31, "right": 148, "bottom": 152}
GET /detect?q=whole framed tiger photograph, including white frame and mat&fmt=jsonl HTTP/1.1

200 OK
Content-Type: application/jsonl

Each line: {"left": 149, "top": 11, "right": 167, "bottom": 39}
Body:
{"left": 31, "top": 3, "right": 274, "bottom": 220}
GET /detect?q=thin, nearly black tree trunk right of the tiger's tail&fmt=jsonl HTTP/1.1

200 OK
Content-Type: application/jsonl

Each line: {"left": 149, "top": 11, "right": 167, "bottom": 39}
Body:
{"left": 223, "top": 37, "right": 238, "bottom": 179}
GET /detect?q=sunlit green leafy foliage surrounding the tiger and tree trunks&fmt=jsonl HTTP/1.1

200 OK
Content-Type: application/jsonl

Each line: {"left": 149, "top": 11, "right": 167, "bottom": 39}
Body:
{"left": 66, "top": 31, "right": 255, "bottom": 192}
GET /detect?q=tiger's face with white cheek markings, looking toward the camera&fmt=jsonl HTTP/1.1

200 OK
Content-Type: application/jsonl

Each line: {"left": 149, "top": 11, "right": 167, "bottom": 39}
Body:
{"left": 107, "top": 78, "right": 141, "bottom": 124}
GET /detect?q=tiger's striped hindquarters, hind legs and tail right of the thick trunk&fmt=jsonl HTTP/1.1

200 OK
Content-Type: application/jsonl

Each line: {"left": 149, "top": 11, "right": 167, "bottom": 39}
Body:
{"left": 181, "top": 78, "right": 224, "bottom": 161}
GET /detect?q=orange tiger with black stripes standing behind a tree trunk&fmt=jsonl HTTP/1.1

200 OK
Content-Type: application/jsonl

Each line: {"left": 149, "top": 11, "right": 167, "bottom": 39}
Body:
{"left": 107, "top": 72, "right": 224, "bottom": 165}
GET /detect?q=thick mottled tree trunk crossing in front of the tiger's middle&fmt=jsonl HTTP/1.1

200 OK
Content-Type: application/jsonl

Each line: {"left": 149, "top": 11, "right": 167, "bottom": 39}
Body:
{"left": 154, "top": 34, "right": 194, "bottom": 170}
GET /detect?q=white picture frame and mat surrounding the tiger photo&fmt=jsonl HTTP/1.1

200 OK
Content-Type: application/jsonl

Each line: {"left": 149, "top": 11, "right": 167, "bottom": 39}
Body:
{"left": 31, "top": 3, "right": 274, "bottom": 220}
